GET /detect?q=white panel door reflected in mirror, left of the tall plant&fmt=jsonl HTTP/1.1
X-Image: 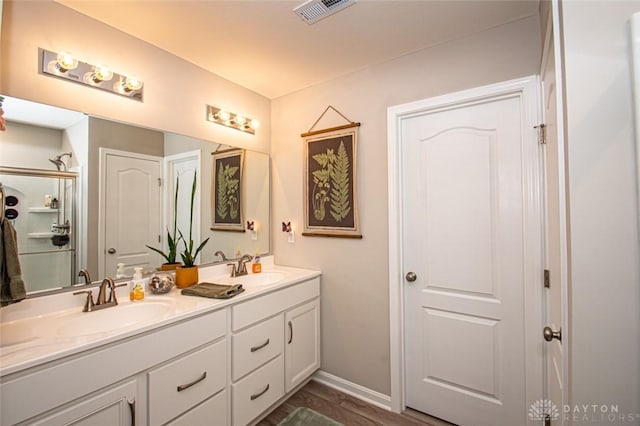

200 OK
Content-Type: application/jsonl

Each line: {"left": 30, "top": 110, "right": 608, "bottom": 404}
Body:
{"left": 100, "top": 152, "right": 162, "bottom": 277}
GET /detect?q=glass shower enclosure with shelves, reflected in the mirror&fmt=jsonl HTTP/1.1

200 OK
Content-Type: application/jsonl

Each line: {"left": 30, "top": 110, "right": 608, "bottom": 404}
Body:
{"left": 0, "top": 166, "right": 78, "bottom": 293}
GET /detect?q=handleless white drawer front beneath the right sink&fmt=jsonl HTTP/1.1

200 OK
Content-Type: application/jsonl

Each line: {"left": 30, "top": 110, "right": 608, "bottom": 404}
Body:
{"left": 231, "top": 278, "right": 320, "bottom": 331}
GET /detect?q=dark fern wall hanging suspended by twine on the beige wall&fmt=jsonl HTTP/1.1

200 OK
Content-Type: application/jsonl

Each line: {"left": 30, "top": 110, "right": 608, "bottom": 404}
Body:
{"left": 300, "top": 106, "right": 362, "bottom": 238}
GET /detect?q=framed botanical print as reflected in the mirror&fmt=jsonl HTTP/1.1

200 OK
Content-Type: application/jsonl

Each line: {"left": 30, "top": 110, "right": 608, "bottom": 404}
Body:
{"left": 211, "top": 149, "right": 245, "bottom": 232}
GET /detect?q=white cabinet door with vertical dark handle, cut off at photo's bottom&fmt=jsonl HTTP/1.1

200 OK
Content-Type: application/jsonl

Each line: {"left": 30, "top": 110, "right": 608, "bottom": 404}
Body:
{"left": 31, "top": 380, "right": 137, "bottom": 426}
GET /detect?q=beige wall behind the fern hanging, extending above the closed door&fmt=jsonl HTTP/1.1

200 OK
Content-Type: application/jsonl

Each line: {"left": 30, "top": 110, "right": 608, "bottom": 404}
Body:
{"left": 271, "top": 18, "right": 540, "bottom": 395}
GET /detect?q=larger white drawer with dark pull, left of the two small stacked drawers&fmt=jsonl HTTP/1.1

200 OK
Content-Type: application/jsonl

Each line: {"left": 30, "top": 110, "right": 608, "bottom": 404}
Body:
{"left": 148, "top": 340, "right": 227, "bottom": 425}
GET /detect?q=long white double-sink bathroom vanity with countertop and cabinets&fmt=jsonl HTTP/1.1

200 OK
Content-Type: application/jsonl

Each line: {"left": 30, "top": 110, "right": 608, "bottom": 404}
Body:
{"left": 0, "top": 258, "right": 320, "bottom": 426}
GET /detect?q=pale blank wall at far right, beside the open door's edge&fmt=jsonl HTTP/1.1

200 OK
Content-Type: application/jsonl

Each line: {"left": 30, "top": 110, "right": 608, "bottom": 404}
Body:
{"left": 563, "top": 1, "right": 640, "bottom": 412}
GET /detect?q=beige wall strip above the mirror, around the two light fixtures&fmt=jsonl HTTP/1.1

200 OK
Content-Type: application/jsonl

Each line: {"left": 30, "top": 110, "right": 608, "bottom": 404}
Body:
{"left": 0, "top": 0, "right": 270, "bottom": 152}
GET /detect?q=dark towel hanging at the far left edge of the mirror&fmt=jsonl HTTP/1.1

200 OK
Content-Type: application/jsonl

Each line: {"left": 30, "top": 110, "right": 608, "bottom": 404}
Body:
{"left": 0, "top": 219, "right": 27, "bottom": 306}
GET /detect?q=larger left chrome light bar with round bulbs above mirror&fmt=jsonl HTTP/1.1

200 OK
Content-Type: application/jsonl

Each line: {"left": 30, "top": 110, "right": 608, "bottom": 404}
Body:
{"left": 39, "top": 49, "right": 143, "bottom": 101}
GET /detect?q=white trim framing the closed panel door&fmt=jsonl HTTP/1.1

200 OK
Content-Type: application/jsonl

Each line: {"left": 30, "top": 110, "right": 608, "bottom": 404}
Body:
{"left": 387, "top": 76, "right": 544, "bottom": 412}
